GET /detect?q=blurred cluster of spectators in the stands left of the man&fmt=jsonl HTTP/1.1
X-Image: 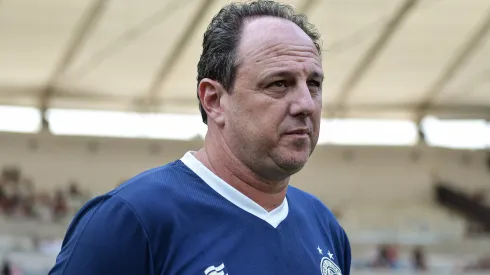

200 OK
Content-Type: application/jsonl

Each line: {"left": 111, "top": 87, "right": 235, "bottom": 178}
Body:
{"left": 0, "top": 167, "right": 89, "bottom": 222}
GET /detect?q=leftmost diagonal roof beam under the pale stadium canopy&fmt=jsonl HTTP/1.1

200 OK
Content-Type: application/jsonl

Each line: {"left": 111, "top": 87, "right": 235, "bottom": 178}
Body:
{"left": 39, "top": 0, "right": 109, "bottom": 127}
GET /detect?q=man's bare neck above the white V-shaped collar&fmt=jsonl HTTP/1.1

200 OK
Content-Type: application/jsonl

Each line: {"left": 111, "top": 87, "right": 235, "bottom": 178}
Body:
{"left": 194, "top": 133, "right": 289, "bottom": 211}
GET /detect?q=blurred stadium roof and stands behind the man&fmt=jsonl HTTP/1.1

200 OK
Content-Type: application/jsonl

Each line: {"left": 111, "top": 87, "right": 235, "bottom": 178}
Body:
{"left": 0, "top": 0, "right": 490, "bottom": 275}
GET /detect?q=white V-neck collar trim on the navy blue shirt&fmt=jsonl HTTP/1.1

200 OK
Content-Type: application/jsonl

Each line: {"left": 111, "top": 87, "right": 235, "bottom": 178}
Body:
{"left": 180, "top": 151, "right": 289, "bottom": 228}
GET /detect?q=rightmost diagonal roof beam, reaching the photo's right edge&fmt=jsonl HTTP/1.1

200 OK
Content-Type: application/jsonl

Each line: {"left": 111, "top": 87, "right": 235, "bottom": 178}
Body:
{"left": 415, "top": 9, "right": 490, "bottom": 121}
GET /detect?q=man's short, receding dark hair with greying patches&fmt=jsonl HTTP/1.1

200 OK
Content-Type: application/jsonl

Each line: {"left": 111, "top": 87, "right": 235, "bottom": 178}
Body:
{"left": 197, "top": 0, "right": 321, "bottom": 124}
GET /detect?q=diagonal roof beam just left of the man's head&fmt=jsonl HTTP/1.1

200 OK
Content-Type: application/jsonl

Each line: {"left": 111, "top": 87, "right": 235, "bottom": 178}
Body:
{"left": 147, "top": 0, "right": 215, "bottom": 110}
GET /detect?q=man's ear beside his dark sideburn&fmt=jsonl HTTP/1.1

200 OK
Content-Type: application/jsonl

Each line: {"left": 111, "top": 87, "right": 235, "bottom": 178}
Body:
{"left": 198, "top": 78, "right": 226, "bottom": 125}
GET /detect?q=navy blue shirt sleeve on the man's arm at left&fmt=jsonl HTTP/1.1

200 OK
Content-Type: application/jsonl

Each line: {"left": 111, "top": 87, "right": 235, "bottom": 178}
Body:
{"left": 49, "top": 196, "right": 153, "bottom": 275}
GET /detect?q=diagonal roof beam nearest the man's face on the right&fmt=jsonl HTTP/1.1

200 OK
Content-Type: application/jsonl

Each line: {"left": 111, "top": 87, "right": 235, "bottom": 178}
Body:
{"left": 330, "top": 0, "right": 418, "bottom": 116}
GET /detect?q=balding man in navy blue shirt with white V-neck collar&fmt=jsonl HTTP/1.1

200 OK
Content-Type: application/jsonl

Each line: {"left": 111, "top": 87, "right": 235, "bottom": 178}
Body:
{"left": 50, "top": 1, "right": 351, "bottom": 275}
